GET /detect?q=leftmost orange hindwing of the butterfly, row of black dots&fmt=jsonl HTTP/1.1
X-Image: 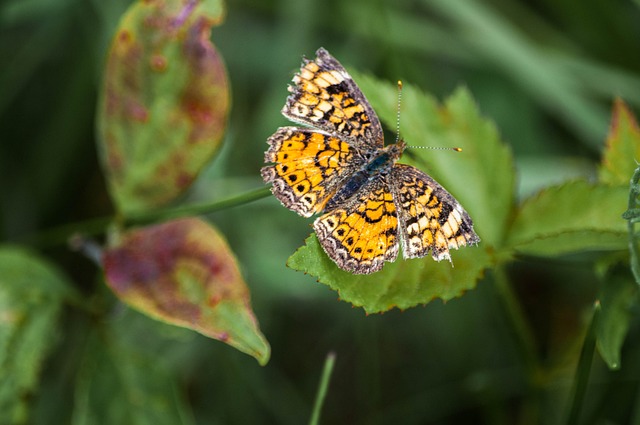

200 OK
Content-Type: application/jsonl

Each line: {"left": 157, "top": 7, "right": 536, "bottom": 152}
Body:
{"left": 260, "top": 127, "right": 364, "bottom": 217}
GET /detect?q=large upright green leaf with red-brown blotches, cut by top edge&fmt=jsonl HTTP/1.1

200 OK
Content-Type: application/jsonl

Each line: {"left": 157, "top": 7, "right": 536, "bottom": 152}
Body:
{"left": 97, "top": 0, "right": 230, "bottom": 213}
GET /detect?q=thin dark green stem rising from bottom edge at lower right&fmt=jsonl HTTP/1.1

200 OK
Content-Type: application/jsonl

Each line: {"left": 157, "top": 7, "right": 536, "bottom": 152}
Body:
{"left": 567, "top": 303, "right": 600, "bottom": 425}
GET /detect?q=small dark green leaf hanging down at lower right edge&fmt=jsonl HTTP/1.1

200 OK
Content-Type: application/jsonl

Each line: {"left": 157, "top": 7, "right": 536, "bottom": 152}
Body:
{"left": 596, "top": 274, "right": 638, "bottom": 369}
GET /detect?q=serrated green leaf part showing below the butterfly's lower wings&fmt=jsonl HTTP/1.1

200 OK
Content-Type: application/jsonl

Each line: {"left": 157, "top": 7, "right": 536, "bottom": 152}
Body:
{"left": 287, "top": 234, "right": 492, "bottom": 313}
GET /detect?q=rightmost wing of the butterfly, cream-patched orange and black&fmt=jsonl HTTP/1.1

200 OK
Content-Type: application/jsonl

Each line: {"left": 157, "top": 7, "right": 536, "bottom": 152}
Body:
{"left": 391, "top": 164, "right": 480, "bottom": 261}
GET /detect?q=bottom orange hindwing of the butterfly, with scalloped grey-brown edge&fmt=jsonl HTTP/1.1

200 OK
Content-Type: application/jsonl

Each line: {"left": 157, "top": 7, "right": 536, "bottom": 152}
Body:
{"left": 313, "top": 173, "right": 399, "bottom": 274}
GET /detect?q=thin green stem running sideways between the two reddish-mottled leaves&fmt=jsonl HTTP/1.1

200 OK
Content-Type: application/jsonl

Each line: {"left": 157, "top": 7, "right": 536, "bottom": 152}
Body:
{"left": 26, "top": 187, "right": 270, "bottom": 248}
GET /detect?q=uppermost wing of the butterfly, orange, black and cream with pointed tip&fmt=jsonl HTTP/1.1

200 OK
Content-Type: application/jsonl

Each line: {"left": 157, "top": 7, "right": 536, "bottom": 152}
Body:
{"left": 282, "top": 48, "right": 384, "bottom": 149}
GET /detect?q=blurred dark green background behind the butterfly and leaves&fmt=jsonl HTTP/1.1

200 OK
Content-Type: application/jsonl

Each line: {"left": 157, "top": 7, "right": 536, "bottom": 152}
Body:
{"left": 0, "top": 0, "right": 640, "bottom": 424}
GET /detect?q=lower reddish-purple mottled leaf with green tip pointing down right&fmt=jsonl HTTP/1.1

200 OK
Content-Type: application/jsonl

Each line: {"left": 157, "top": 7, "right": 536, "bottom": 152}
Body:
{"left": 103, "top": 218, "right": 270, "bottom": 365}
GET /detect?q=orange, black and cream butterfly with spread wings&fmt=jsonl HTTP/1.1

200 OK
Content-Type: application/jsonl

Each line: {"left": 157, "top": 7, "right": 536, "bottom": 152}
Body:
{"left": 261, "top": 48, "right": 480, "bottom": 274}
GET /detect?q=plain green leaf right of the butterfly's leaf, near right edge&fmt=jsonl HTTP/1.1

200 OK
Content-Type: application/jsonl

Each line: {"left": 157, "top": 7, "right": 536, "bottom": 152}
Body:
{"left": 507, "top": 180, "right": 628, "bottom": 256}
